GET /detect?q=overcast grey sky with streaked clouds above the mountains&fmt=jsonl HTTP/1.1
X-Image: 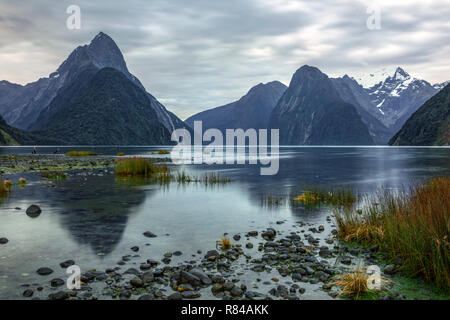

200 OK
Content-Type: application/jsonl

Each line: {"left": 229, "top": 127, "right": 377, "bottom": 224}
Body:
{"left": 0, "top": 0, "right": 450, "bottom": 119}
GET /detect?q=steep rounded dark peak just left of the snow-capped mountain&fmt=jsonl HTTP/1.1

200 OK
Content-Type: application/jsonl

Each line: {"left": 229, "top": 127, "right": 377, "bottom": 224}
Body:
{"left": 270, "top": 65, "right": 374, "bottom": 145}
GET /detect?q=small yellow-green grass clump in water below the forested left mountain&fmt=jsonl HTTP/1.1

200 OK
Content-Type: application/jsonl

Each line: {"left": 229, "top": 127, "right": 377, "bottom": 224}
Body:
{"left": 116, "top": 157, "right": 170, "bottom": 177}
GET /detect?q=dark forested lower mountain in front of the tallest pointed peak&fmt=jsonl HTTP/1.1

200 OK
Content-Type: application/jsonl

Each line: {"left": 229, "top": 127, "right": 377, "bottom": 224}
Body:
{"left": 34, "top": 68, "right": 170, "bottom": 145}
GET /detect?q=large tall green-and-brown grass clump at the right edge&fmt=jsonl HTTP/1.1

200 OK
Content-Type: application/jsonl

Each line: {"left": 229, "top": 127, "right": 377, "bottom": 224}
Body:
{"left": 335, "top": 177, "right": 450, "bottom": 290}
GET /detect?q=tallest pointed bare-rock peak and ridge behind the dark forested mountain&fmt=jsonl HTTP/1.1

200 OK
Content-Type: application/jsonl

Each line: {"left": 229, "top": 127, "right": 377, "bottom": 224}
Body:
{"left": 0, "top": 32, "right": 187, "bottom": 136}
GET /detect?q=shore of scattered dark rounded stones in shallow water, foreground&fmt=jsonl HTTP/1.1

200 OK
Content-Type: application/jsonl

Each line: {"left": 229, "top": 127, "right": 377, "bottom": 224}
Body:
{"left": 14, "top": 217, "right": 405, "bottom": 300}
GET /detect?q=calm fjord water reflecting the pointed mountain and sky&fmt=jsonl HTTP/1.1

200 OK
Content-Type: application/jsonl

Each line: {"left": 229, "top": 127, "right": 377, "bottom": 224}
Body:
{"left": 0, "top": 147, "right": 450, "bottom": 299}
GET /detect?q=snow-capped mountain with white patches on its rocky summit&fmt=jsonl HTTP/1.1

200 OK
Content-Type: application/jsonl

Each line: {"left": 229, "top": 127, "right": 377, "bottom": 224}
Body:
{"left": 332, "top": 67, "right": 448, "bottom": 144}
